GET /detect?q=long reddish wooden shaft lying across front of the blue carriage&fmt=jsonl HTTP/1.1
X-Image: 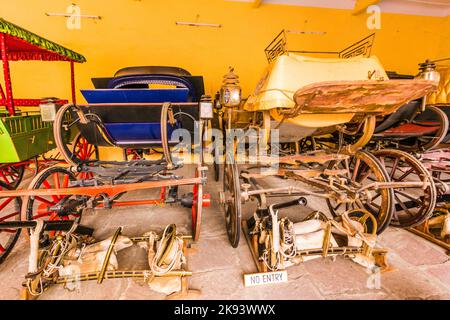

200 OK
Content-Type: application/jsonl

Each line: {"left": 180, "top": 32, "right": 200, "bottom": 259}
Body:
{"left": 0, "top": 177, "right": 204, "bottom": 198}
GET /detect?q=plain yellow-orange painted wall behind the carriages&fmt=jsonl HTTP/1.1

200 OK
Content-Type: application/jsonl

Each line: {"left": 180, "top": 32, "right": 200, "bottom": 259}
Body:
{"left": 0, "top": 0, "right": 450, "bottom": 101}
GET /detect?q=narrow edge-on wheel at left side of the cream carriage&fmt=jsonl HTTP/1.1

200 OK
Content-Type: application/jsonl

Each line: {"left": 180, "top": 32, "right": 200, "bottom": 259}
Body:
{"left": 221, "top": 157, "right": 242, "bottom": 248}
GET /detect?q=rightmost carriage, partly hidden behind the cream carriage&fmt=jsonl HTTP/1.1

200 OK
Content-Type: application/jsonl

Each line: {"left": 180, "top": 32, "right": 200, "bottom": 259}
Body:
{"left": 338, "top": 59, "right": 450, "bottom": 245}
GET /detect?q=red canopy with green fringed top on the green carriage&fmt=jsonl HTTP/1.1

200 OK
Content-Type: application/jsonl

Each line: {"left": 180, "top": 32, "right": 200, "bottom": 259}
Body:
{"left": 0, "top": 18, "right": 86, "bottom": 63}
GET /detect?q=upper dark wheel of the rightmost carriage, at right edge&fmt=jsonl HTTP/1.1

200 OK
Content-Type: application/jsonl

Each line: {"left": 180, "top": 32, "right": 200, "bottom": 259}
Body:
{"left": 399, "top": 106, "right": 449, "bottom": 152}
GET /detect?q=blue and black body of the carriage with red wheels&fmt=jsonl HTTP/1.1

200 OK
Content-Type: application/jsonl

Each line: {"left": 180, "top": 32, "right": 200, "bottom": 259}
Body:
{"left": 77, "top": 66, "right": 204, "bottom": 148}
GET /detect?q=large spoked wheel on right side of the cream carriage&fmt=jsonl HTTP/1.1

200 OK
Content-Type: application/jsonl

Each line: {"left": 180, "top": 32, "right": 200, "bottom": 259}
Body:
{"left": 327, "top": 151, "right": 394, "bottom": 234}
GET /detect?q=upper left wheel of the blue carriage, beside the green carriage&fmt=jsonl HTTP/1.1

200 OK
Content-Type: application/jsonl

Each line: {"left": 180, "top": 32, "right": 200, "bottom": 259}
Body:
{"left": 53, "top": 105, "right": 99, "bottom": 166}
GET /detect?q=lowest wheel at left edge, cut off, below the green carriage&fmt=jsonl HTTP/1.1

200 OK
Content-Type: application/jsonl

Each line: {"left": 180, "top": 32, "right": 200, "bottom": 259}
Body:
{"left": 0, "top": 181, "right": 22, "bottom": 263}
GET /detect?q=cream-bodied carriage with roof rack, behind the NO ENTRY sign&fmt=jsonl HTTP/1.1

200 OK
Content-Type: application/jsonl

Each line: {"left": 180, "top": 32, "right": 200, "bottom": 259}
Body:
{"left": 215, "top": 32, "right": 437, "bottom": 272}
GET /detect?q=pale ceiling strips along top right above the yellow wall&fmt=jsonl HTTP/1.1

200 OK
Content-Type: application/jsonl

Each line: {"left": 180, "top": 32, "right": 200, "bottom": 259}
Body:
{"left": 232, "top": 0, "right": 450, "bottom": 17}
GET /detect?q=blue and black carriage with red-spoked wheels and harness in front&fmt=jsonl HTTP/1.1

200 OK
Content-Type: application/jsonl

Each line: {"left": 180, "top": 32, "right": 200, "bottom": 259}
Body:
{"left": 0, "top": 63, "right": 212, "bottom": 297}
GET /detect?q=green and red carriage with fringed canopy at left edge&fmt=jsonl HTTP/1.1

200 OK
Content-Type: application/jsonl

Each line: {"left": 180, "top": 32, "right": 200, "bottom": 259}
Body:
{"left": 0, "top": 19, "right": 98, "bottom": 263}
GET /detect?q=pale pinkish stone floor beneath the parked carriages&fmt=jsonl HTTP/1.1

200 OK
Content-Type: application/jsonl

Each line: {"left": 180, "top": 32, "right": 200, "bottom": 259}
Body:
{"left": 0, "top": 168, "right": 450, "bottom": 300}
